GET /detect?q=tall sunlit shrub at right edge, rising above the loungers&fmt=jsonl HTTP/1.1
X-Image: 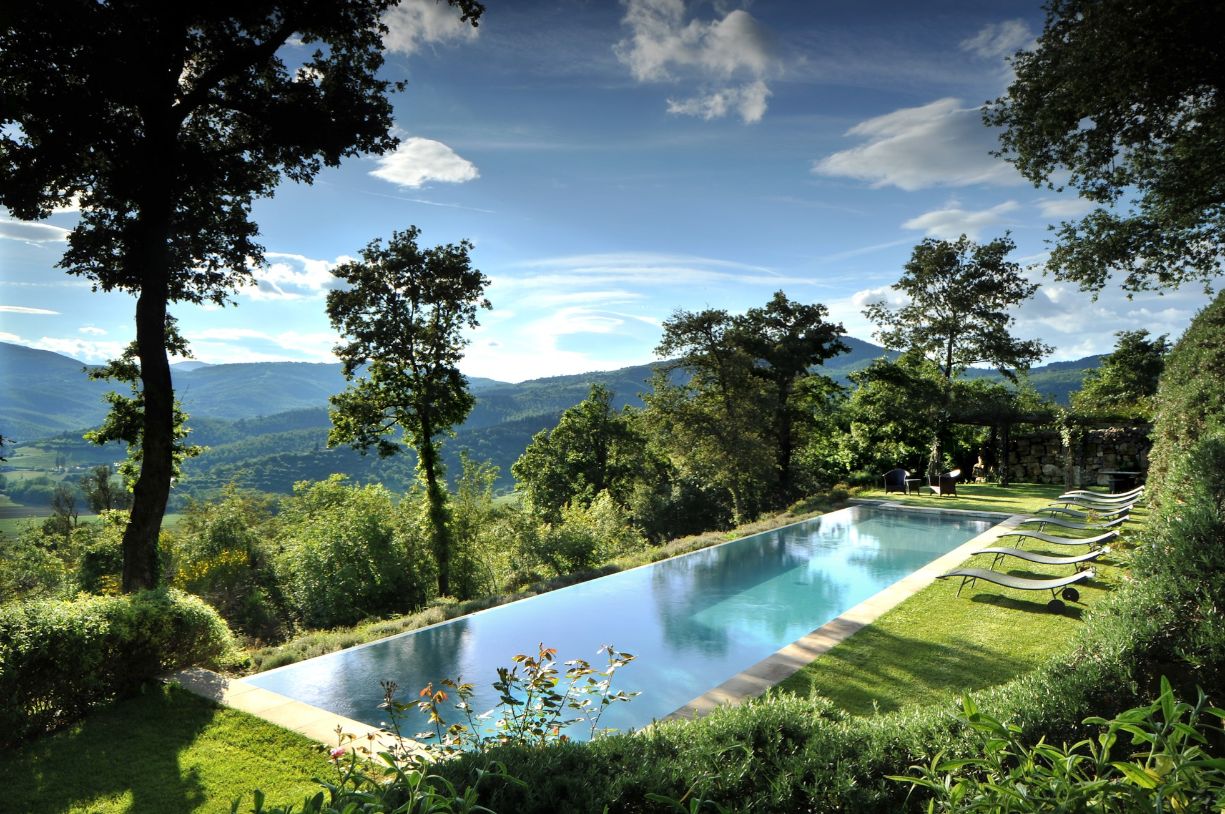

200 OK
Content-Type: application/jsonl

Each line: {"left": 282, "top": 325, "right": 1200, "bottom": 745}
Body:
{"left": 1148, "top": 292, "right": 1225, "bottom": 504}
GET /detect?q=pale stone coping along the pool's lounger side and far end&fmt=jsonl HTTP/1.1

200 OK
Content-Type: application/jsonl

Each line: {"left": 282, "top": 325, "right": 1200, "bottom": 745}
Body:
{"left": 663, "top": 500, "right": 1028, "bottom": 721}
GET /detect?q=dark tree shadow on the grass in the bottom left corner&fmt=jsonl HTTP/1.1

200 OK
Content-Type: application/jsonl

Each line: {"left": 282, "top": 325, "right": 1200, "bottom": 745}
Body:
{"left": 0, "top": 687, "right": 218, "bottom": 814}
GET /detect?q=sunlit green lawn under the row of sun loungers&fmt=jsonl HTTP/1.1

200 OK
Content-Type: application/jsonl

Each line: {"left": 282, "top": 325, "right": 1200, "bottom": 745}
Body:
{"left": 771, "top": 484, "right": 1145, "bottom": 713}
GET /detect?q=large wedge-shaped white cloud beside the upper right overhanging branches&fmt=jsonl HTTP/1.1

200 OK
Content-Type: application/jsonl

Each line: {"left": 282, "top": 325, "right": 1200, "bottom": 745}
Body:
{"left": 812, "top": 98, "right": 1023, "bottom": 191}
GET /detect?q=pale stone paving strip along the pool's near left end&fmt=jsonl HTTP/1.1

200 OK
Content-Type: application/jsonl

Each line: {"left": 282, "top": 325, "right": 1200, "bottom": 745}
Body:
{"left": 168, "top": 667, "right": 414, "bottom": 753}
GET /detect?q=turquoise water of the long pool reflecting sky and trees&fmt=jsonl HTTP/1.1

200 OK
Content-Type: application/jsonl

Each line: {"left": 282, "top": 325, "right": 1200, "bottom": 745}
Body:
{"left": 245, "top": 506, "right": 992, "bottom": 737}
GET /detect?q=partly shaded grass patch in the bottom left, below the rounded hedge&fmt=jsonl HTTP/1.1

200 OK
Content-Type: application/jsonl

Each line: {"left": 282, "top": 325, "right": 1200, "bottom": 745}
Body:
{"left": 0, "top": 688, "right": 333, "bottom": 814}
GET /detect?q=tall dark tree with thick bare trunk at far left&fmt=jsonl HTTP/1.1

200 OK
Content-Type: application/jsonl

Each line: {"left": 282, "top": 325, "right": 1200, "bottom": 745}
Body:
{"left": 0, "top": 0, "right": 483, "bottom": 591}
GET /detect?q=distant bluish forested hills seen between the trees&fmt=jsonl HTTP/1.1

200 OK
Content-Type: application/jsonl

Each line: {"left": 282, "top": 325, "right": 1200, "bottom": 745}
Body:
{"left": 0, "top": 337, "right": 1100, "bottom": 499}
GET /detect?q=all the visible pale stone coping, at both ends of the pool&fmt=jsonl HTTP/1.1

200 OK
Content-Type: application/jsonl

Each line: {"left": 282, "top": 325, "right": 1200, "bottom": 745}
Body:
{"left": 168, "top": 499, "right": 1028, "bottom": 740}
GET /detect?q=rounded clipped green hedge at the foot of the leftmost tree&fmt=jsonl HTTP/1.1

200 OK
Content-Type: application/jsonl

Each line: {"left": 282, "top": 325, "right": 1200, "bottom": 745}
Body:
{"left": 0, "top": 590, "right": 236, "bottom": 743}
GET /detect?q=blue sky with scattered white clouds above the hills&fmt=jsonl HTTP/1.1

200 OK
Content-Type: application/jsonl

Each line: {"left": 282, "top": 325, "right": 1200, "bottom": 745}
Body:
{"left": 0, "top": 0, "right": 1208, "bottom": 381}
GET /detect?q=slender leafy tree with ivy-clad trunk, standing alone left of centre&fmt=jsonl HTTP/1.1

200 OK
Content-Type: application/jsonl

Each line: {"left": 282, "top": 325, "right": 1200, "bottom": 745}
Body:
{"left": 327, "top": 227, "right": 489, "bottom": 596}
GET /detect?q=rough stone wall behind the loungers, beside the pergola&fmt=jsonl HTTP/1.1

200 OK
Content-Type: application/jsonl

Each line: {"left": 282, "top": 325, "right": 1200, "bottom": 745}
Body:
{"left": 1008, "top": 427, "right": 1153, "bottom": 487}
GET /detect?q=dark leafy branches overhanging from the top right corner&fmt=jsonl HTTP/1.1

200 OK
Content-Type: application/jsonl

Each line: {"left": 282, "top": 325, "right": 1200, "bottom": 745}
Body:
{"left": 985, "top": 0, "right": 1225, "bottom": 292}
